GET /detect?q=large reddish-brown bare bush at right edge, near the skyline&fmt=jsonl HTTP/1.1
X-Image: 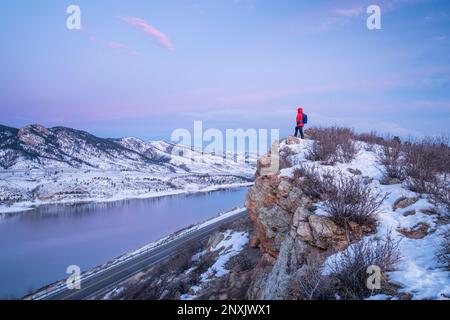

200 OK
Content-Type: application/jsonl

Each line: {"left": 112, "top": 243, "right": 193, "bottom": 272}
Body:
{"left": 404, "top": 136, "right": 450, "bottom": 193}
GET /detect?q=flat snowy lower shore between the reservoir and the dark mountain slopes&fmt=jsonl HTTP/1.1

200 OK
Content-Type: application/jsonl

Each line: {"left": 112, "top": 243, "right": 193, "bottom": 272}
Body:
{"left": 0, "top": 167, "right": 253, "bottom": 214}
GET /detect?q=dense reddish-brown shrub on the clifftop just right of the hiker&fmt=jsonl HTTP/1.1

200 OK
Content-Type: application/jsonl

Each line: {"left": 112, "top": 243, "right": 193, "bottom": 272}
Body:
{"left": 307, "top": 126, "right": 358, "bottom": 165}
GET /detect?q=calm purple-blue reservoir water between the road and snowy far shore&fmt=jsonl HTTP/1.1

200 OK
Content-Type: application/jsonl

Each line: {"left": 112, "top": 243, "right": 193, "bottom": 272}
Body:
{"left": 0, "top": 188, "right": 247, "bottom": 299}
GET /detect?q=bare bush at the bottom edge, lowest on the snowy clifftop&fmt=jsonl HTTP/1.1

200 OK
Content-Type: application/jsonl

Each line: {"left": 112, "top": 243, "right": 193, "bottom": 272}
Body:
{"left": 328, "top": 233, "right": 400, "bottom": 300}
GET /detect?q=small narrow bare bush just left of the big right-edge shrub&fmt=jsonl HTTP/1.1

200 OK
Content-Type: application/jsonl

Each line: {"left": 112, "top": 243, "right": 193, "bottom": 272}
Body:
{"left": 378, "top": 140, "right": 405, "bottom": 181}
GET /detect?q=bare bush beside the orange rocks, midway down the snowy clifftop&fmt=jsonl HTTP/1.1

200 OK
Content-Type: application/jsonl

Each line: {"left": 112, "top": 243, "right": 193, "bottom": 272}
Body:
{"left": 324, "top": 172, "right": 388, "bottom": 228}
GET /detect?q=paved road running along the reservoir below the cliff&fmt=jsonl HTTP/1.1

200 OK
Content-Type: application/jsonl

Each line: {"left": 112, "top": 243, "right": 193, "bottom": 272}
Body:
{"left": 37, "top": 211, "right": 247, "bottom": 300}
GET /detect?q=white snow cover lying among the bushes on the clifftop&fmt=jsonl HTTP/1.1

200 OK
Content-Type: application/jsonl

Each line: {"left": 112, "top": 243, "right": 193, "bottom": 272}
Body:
{"left": 281, "top": 140, "right": 450, "bottom": 299}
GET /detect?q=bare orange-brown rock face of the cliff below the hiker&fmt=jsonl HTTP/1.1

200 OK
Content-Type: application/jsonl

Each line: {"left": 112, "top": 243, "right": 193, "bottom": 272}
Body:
{"left": 245, "top": 137, "right": 371, "bottom": 299}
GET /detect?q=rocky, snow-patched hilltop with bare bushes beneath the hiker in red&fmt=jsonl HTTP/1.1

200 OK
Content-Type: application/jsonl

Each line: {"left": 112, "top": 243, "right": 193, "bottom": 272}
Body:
{"left": 246, "top": 129, "right": 450, "bottom": 300}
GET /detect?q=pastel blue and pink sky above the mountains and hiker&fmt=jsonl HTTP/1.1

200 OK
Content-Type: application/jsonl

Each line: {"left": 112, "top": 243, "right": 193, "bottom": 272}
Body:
{"left": 0, "top": 0, "right": 450, "bottom": 139}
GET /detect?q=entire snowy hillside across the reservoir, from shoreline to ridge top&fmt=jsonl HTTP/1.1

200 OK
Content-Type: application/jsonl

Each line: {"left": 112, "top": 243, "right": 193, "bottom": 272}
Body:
{"left": 0, "top": 125, "right": 255, "bottom": 212}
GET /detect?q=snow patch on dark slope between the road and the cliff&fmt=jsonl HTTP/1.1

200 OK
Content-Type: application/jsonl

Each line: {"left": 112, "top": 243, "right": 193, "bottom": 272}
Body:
{"left": 180, "top": 230, "right": 249, "bottom": 300}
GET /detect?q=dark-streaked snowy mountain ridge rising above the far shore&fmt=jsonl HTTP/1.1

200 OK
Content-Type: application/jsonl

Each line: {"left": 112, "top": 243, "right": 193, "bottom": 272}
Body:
{"left": 0, "top": 125, "right": 253, "bottom": 173}
